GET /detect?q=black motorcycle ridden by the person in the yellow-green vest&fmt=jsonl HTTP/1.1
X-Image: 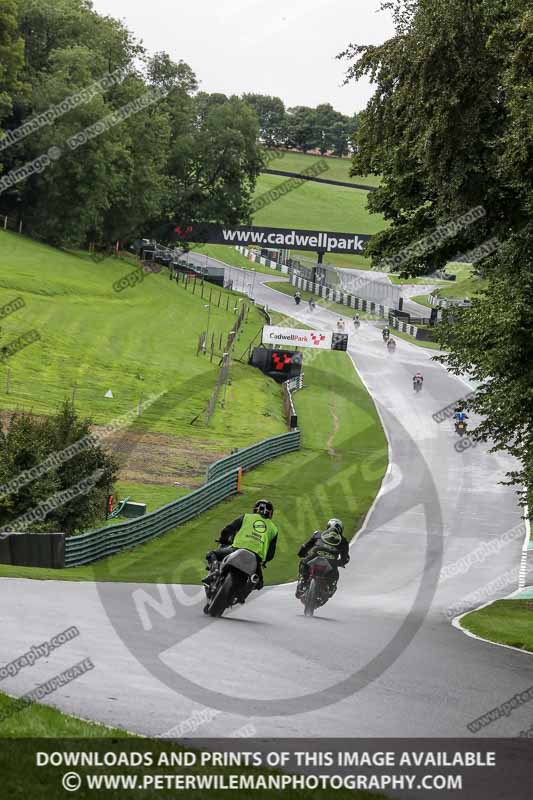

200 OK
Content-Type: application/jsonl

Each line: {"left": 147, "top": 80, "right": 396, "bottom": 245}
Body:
{"left": 204, "top": 548, "right": 260, "bottom": 617}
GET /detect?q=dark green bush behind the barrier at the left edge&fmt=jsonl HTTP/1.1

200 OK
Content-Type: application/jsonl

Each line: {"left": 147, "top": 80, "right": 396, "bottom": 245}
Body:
{"left": 0, "top": 402, "right": 117, "bottom": 534}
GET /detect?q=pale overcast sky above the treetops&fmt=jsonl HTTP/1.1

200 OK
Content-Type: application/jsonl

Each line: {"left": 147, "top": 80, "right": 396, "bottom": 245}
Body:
{"left": 90, "top": 0, "right": 392, "bottom": 114}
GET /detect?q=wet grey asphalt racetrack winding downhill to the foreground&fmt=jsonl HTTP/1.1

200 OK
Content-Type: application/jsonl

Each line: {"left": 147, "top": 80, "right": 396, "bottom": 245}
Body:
{"left": 0, "top": 268, "right": 533, "bottom": 738}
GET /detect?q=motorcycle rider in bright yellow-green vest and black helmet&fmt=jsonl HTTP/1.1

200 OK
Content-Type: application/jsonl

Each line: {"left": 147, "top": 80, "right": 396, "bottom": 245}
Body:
{"left": 202, "top": 500, "right": 278, "bottom": 602}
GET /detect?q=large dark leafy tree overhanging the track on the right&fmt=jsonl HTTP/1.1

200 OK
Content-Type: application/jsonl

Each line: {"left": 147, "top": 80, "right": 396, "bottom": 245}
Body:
{"left": 340, "top": 0, "right": 533, "bottom": 497}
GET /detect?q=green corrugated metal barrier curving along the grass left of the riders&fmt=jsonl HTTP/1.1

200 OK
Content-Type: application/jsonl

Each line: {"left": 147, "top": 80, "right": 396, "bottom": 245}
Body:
{"left": 65, "top": 430, "right": 300, "bottom": 567}
